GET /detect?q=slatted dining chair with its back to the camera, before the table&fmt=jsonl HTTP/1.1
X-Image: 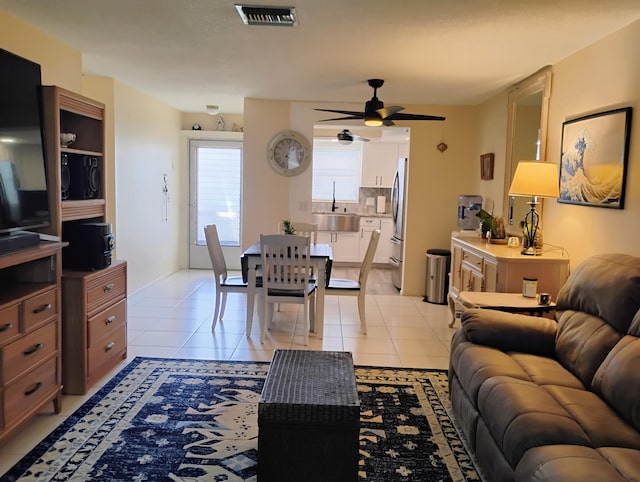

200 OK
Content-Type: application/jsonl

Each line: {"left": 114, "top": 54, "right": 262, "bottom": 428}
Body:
{"left": 260, "top": 234, "right": 316, "bottom": 345}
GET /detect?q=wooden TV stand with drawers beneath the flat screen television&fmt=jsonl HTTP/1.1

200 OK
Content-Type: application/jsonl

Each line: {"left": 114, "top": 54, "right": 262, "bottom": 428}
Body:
{"left": 0, "top": 242, "right": 63, "bottom": 440}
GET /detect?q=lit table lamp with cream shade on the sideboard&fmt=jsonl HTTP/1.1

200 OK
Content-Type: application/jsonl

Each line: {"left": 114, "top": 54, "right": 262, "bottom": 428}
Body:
{"left": 509, "top": 161, "right": 560, "bottom": 255}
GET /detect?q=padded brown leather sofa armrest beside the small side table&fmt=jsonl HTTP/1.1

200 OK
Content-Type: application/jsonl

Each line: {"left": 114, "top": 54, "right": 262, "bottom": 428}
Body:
{"left": 461, "top": 308, "right": 557, "bottom": 356}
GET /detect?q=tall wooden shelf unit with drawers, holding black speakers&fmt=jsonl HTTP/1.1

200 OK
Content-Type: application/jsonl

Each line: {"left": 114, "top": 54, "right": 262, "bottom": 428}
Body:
{"left": 43, "top": 86, "right": 127, "bottom": 394}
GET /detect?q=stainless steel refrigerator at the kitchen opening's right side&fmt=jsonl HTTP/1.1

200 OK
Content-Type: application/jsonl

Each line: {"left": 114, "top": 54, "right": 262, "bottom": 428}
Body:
{"left": 389, "top": 157, "right": 407, "bottom": 289}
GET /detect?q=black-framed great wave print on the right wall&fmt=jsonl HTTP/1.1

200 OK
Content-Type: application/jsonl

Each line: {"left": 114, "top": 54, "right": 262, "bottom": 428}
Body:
{"left": 558, "top": 107, "right": 632, "bottom": 209}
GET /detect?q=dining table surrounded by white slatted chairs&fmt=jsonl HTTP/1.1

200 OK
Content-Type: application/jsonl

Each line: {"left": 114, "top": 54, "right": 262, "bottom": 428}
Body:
{"left": 240, "top": 242, "right": 333, "bottom": 338}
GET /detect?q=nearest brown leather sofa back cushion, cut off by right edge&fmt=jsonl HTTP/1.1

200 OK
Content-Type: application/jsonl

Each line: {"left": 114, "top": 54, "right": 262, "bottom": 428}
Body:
{"left": 593, "top": 336, "right": 640, "bottom": 430}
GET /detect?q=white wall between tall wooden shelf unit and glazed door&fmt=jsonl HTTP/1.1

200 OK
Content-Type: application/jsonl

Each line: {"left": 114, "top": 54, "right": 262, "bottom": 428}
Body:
{"left": 113, "top": 81, "right": 182, "bottom": 293}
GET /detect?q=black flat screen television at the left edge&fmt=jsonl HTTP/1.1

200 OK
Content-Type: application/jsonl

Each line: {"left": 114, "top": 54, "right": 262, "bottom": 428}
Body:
{"left": 0, "top": 49, "right": 51, "bottom": 236}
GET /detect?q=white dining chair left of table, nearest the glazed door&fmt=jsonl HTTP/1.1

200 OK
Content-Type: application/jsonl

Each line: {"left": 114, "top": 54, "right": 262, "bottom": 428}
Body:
{"left": 204, "top": 224, "right": 251, "bottom": 336}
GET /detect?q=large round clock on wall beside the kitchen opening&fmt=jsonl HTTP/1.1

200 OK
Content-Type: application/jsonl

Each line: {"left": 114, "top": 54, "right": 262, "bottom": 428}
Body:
{"left": 267, "top": 131, "right": 311, "bottom": 176}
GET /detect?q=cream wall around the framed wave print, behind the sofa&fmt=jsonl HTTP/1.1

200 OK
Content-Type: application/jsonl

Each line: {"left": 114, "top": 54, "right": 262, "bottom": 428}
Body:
{"left": 543, "top": 21, "right": 640, "bottom": 266}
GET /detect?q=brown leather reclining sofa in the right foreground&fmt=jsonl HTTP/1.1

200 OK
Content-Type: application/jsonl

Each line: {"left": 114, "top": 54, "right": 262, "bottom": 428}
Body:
{"left": 449, "top": 254, "right": 640, "bottom": 482}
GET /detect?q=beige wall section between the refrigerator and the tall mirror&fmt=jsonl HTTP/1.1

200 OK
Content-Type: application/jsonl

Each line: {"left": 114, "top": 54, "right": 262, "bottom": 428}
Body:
{"left": 397, "top": 105, "right": 480, "bottom": 296}
